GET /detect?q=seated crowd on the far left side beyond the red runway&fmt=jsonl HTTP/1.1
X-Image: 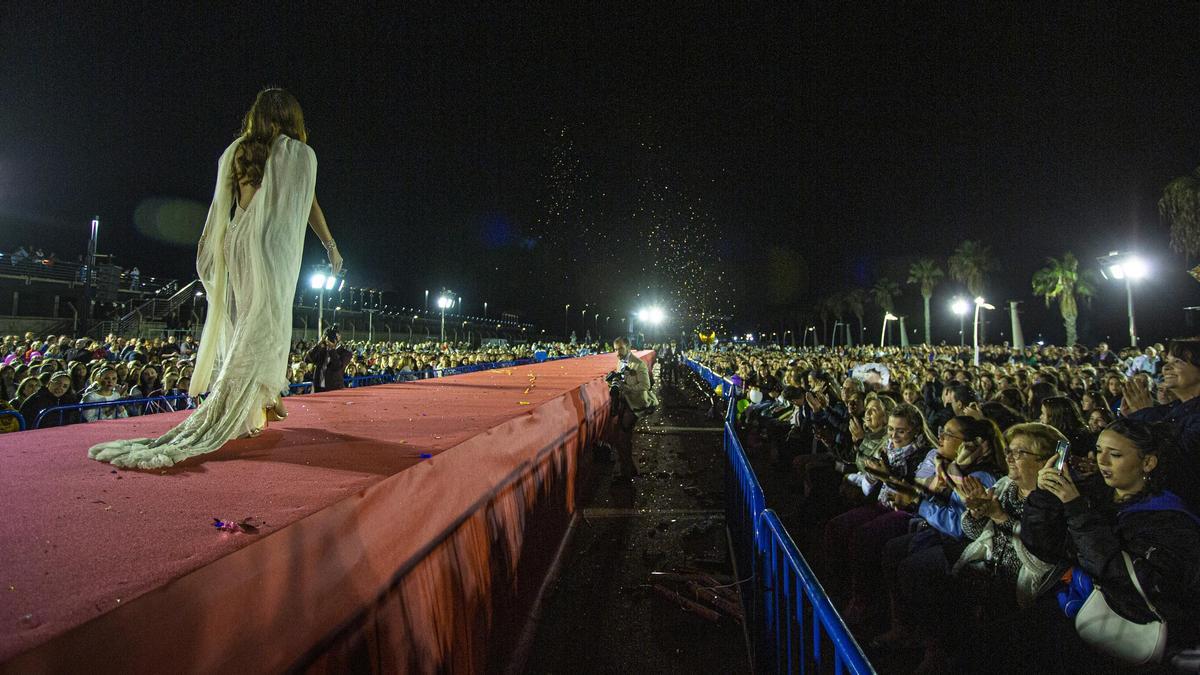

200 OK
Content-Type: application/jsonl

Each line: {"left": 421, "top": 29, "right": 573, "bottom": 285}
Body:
{"left": 0, "top": 333, "right": 590, "bottom": 432}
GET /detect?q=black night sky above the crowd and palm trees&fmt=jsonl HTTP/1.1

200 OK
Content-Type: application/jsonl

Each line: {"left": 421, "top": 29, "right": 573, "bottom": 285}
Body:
{"left": 0, "top": 2, "right": 1200, "bottom": 344}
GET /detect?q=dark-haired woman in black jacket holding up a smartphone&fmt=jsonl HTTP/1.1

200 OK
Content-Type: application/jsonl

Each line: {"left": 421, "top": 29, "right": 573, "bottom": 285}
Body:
{"left": 1021, "top": 418, "right": 1200, "bottom": 671}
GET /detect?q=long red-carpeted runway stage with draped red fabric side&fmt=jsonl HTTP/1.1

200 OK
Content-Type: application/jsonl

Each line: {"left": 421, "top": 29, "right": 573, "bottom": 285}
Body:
{"left": 0, "top": 353, "right": 653, "bottom": 673}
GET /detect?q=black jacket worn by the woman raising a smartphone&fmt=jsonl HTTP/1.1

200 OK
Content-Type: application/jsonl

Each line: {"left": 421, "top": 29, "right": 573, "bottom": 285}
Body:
{"left": 1021, "top": 485, "right": 1200, "bottom": 629}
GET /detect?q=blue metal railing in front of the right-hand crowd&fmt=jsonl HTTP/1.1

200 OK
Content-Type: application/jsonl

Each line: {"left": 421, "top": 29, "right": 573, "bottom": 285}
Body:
{"left": 686, "top": 359, "right": 875, "bottom": 675}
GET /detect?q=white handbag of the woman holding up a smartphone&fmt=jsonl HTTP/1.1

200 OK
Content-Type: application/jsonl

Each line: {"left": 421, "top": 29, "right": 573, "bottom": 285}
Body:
{"left": 1075, "top": 551, "right": 1166, "bottom": 665}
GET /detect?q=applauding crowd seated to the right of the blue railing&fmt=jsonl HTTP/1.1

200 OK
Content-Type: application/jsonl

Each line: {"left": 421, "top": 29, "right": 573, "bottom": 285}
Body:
{"left": 690, "top": 339, "right": 1200, "bottom": 673}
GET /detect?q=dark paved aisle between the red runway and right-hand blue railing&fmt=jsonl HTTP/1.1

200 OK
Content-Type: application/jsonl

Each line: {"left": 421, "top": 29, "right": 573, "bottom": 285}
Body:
{"left": 526, "top": 367, "right": 749, "bottom": 674}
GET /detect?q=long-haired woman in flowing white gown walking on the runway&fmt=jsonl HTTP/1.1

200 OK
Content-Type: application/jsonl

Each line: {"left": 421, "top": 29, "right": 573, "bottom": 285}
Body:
{"left": 88, "top": 89, "right": 342, "bottom": 468}
